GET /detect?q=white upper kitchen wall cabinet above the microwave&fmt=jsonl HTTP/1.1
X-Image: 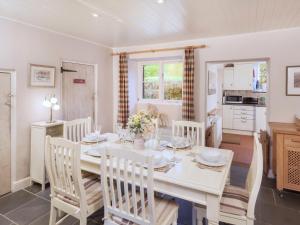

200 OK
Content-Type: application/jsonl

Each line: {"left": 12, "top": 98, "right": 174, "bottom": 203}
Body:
{"left": 223, "top": 63, "right": 253, "bottom": 91}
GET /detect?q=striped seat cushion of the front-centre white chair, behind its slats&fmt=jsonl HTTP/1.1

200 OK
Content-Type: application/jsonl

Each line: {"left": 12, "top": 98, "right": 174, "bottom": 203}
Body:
{"left": 112, "top": 196, "right": 178, "bottom": 225}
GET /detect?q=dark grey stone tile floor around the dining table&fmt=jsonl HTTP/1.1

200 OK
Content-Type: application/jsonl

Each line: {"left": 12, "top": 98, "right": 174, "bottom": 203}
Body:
{"left": 0, "top": 165, "right": 300, "bottom": 225}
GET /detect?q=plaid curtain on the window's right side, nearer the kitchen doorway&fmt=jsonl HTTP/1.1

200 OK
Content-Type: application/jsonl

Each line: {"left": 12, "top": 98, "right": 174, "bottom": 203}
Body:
{"left": 182, "top": 47, "right": 195, "bottom": 120}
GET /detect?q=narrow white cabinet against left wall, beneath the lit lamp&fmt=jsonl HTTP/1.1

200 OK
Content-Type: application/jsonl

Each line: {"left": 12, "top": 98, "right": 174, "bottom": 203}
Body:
{"left": 30, "top": 121, "right": 64, "bottom": 190}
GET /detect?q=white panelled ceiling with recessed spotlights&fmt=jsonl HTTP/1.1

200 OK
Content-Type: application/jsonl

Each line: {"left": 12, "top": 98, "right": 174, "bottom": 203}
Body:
{"left": 0, "top": 0, "right": 300, "bottom": 47}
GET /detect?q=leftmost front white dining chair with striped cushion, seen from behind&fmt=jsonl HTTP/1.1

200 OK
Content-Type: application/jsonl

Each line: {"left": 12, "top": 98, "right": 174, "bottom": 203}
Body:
{"left": 45, "top": 136, "right": 103, "bottom": 225}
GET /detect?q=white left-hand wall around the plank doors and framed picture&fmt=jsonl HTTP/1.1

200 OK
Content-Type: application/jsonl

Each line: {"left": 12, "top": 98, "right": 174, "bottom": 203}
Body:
{"left": 0, "top": 19, "right": 113, "bottom": 183}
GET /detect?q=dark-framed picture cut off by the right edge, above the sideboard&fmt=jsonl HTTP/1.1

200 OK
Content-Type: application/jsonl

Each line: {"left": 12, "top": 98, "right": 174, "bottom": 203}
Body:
{"left": 286, "top": 66, "right": 300, "bottom": 96}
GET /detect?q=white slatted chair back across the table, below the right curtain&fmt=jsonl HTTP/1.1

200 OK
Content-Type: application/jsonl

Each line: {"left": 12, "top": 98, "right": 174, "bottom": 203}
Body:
{"left": 172, "top": 120, "right": 205, "bottom": 146}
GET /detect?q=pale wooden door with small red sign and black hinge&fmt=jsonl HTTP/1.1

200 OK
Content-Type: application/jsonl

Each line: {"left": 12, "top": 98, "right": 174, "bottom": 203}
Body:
{"left": 62, "top": 62, "right": 96, "bottom": 122}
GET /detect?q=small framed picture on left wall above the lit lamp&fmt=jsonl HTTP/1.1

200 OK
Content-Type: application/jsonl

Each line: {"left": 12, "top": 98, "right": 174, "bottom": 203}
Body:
{"left": 30, "top": 64, "right": 55, "bottom": 87}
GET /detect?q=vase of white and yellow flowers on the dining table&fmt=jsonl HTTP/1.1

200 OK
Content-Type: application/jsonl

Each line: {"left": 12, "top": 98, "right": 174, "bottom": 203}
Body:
{"left": 127, "top": 112, "right": 154, "bottom": 149}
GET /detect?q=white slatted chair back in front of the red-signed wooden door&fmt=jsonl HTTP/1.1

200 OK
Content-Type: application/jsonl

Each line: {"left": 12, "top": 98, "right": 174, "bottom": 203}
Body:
{"left": 64, "top": 117, "right": 92, "bottom": 142}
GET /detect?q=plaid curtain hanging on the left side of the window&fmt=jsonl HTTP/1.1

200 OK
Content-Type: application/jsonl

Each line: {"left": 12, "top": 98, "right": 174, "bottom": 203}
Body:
{"left": 118, "top": 53, "right": 129, "bottom": 128}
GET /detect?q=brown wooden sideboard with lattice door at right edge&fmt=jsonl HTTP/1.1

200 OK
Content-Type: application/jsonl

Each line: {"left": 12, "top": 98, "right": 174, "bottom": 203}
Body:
{"left": 269, "top": 122, "right": 300, "bottom": 191}
